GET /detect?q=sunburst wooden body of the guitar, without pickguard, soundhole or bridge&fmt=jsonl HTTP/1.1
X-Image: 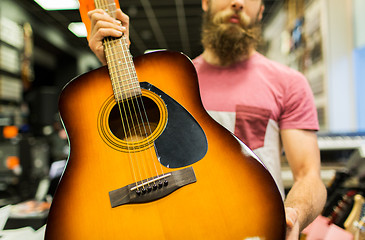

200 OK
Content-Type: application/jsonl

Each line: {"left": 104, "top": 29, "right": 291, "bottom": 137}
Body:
{"left": 46, "top": 52, "right": 285, "bottom": 240}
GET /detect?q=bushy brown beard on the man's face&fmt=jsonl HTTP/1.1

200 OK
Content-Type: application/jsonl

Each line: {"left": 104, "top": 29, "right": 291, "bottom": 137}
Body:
{"left": 202, "top": 10, "right": 261, "bottom": 66}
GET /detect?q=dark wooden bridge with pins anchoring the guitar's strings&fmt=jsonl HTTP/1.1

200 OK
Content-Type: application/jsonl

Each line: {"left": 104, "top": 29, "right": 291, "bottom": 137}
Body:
{"left": 109, "top": 167, "right": 196, "bottom": 208}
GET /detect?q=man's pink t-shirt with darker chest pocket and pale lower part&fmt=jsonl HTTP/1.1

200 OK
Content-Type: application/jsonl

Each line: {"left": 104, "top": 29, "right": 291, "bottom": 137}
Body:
{"left": 193, "top": 53, "right": 319, "bottom": 197}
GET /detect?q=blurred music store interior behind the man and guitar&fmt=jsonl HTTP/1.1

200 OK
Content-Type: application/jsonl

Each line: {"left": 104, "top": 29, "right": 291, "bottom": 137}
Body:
{"left": 0, "top": 0, "right": 365, "bottom": 239}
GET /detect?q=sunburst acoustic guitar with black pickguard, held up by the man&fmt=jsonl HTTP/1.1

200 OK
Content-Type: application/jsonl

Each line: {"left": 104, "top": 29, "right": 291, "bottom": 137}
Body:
{"left": 45, "top": 0, "right": 286, "bottom": 240}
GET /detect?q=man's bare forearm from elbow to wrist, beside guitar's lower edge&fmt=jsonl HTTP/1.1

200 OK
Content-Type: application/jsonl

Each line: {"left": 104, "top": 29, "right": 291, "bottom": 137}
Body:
{"left": 285, "top": 174, "right": 326, "bottom": 231}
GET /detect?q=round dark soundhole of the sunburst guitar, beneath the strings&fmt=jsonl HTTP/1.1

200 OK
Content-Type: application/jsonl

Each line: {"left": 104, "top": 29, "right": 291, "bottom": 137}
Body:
{"left": 108, "top": 96, "right": 160, "bottom": 142}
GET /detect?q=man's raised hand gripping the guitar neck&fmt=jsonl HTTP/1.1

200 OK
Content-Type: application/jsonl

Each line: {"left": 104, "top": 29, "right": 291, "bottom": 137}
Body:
{"left": 88, "top": 9, "right": 129, "bottom": 65}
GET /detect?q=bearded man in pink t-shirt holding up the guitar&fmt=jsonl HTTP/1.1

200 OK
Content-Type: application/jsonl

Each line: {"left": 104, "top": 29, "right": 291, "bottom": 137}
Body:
{"left": 84, "top": 0, "right": 326, "bottom": 240}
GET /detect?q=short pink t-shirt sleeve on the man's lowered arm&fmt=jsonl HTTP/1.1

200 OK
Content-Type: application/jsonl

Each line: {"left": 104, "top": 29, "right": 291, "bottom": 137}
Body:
{"left": 279, "top": 72, "right": 319, "bottom": 131}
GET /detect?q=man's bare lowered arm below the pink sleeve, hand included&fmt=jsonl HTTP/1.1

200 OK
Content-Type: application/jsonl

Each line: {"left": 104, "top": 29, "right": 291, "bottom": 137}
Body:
{"left": 281, "top": 129, "right": 326, "bottom": 240}
